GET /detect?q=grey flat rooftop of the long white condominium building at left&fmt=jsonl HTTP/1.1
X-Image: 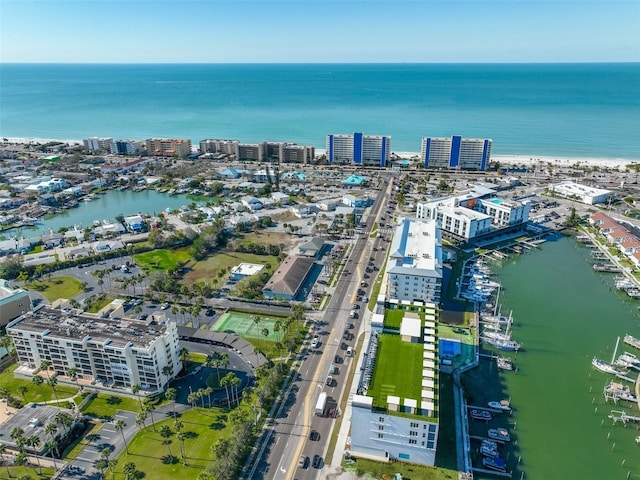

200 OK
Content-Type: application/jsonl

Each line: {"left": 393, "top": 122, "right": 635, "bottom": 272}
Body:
{"left": 9, "top": 307, "right": 166, "bottom": 347}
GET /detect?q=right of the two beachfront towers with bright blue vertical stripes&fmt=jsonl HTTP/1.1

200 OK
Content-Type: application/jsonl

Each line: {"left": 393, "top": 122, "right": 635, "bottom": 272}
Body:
{"left": 420, "top": 135, "right": 491, "bottom": 171}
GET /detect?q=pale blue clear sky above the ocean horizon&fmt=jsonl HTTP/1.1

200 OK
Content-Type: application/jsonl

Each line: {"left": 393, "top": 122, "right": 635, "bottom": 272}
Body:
{"left": 0, "top": 0, "right": 640, "bottom": 63}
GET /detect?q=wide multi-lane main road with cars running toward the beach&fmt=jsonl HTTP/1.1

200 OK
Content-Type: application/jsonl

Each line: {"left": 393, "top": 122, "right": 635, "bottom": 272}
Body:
{"left": 251, "top": 177, "right": 393, "bottom": 480}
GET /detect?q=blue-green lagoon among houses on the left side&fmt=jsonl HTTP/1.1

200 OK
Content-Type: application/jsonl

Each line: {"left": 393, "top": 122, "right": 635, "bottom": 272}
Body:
{"left": 12, "top": 190, "right": 192, "bottom": 237}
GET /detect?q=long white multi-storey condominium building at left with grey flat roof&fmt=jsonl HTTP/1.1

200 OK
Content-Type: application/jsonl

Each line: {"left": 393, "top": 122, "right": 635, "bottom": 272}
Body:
{"left": 7, "top": 307, "right": 182, "bottom": 393}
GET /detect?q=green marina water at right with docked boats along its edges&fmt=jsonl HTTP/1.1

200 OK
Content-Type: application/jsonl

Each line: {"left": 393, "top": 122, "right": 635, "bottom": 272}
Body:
{"left": 476, "top": 237, "right": 640, "bottom": 480}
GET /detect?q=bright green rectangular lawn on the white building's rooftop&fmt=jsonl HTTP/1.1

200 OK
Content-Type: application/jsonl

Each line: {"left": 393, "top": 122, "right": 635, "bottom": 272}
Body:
{"left": 367, "top": 334, "right": 424, "bottom": 408}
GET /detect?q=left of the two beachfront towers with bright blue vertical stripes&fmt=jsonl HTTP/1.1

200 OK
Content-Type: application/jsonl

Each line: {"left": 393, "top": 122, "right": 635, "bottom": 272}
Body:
{"left": 327, "top": 132, "right": 391, "bottom": 167}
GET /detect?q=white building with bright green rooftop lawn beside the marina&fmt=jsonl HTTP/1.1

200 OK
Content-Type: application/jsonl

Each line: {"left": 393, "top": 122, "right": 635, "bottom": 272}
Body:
{"left": 349, "top": 305, "right": 439, "bottom": 465}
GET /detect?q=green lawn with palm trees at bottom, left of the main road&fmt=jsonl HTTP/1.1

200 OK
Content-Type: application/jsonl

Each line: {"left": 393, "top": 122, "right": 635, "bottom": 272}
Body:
{"left": 115, "top": 408, "right": 230, "bottom": 480}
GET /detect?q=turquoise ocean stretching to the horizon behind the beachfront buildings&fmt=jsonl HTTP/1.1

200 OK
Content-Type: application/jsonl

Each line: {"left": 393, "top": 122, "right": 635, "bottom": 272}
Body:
{"left": 0, "top": 63, "right": 640, "bottom": 160}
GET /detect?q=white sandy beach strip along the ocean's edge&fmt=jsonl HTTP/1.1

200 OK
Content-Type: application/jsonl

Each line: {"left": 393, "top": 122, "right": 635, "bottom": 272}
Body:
{"left": 5, "top": 137, "right": 640, "bottom": 170}
